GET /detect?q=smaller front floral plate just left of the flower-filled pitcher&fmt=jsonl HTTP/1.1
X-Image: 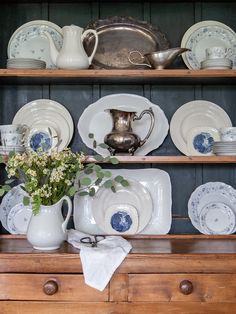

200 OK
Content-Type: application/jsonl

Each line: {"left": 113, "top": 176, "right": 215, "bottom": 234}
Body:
{"left": 7, "top": 203, "right": 32, "bottom": 234}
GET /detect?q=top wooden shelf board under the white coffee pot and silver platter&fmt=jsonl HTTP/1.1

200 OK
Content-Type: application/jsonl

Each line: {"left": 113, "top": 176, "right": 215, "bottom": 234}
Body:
{"left": 0, "top": 69, "right": 236, "bottom": 84}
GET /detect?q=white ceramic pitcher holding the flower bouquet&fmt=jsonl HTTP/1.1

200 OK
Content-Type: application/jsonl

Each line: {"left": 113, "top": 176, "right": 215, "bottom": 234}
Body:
{"left": 27, "top": 196, "right": 72, "bottom": 251}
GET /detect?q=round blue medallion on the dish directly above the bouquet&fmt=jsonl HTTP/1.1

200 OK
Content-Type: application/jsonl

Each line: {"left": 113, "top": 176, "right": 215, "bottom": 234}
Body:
{"left": 30, "top": 132, "right": 52, "bottom": 152}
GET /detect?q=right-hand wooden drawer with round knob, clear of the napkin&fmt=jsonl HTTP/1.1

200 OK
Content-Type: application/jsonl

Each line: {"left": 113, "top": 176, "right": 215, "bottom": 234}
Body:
{"left": 128, "top": 274, "right": 236, "bottom": 303}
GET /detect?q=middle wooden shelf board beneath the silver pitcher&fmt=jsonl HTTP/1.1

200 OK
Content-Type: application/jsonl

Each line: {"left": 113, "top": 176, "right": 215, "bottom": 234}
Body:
{"left": 86, "top": 156, "right": 236, "bottom": 164}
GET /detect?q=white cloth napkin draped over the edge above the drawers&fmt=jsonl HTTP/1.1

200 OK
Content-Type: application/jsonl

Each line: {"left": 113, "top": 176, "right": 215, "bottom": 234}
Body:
{"left": 67, "top": 229, "right": 132, "bottom": 291}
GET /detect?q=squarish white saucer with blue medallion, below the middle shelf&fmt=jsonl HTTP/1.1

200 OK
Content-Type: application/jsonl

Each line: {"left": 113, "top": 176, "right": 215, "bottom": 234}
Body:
{"left": 103, "top": 204, "right": 139, "bottom": 234}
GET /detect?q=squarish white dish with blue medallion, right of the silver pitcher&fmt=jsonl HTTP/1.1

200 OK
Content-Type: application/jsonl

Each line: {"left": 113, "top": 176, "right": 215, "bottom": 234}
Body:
{"left": 187, "top": 127, "right": 220, "bottom": 156}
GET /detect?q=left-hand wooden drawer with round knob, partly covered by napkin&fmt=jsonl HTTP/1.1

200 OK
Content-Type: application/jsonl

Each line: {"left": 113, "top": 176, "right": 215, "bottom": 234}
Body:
{"left": 0, "top": 274, "right": 108, "bottom": 302}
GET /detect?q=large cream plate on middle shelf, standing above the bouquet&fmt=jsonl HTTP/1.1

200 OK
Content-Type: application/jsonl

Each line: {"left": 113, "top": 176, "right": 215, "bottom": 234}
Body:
{"left": 13, "top": 99, "right": 74, "bottom": 151}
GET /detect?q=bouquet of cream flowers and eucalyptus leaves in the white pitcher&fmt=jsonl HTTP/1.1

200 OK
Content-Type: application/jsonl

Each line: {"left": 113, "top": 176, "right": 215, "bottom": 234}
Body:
{"left": 0, "top": 148, "right": 129, "bottom": 214}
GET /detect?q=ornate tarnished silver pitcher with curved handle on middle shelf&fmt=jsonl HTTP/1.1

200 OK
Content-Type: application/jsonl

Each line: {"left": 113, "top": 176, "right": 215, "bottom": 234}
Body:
{"left": 104, "top": 108, "right": 155, "bottom": 155}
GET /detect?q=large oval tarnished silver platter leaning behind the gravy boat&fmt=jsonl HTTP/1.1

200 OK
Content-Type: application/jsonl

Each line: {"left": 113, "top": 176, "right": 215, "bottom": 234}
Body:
{"left": 84, "top": 16, "right": 169, "bottom": 69}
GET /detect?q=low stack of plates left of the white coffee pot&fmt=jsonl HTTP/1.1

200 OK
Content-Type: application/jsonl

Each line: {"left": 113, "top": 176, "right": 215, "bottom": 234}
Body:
{"left": 7, "top": 58, "right": 46, "bottom": 69}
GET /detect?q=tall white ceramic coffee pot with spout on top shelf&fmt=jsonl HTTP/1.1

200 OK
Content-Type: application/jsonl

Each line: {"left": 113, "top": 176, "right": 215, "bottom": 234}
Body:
{"left": 45, "top": 25, "right": 98, "bottom": 69}
